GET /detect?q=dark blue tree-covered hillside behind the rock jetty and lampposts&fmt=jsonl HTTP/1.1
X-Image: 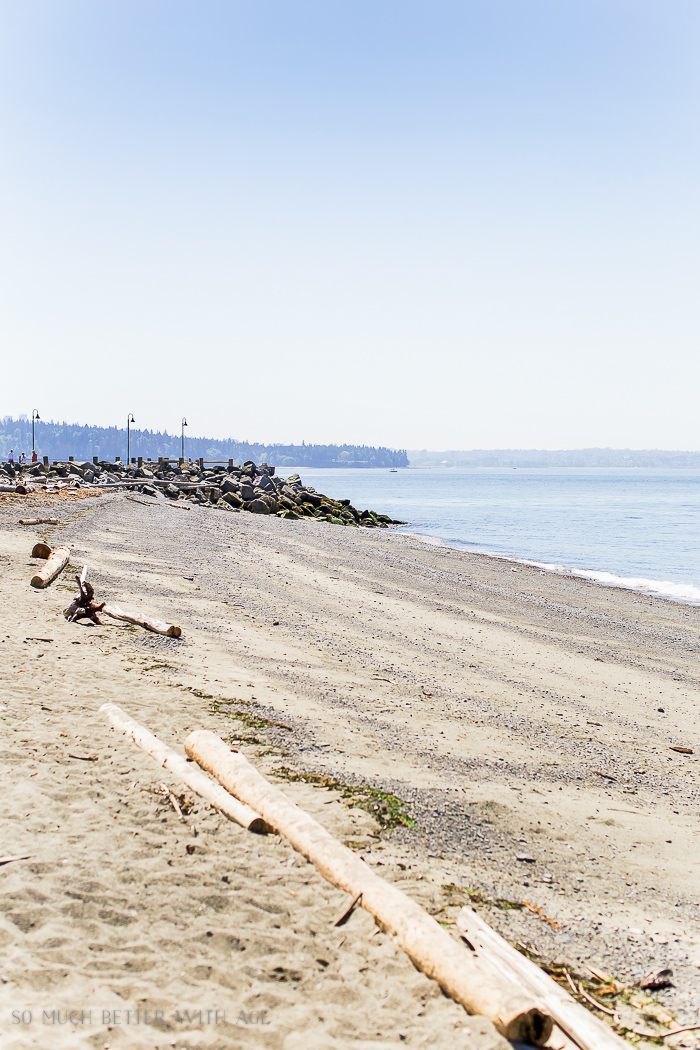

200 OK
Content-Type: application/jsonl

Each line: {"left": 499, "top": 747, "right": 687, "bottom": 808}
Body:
{"left": 0, "top": 416, "right": 408, "bottom": 467}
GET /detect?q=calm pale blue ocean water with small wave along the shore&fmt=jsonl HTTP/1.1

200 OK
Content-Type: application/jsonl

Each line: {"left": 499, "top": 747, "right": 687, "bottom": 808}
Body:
{"left": 299, "top": 467, "right": 700, "bottom": 604}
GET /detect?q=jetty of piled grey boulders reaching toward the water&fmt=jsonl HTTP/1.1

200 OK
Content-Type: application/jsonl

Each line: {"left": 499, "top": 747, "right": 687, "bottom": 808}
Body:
{"left": 0, "top": 460, "right": 405, "bottom": 528}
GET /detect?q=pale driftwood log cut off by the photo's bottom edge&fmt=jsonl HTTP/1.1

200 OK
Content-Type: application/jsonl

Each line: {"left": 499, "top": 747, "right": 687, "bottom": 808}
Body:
{"left": 457, "top": 907, "right": 629, "bottom": 1050}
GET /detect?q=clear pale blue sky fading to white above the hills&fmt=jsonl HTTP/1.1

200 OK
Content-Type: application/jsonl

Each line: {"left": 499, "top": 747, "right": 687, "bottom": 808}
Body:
{"left": 0, "top": 0, "right": 700, "bottom": 448}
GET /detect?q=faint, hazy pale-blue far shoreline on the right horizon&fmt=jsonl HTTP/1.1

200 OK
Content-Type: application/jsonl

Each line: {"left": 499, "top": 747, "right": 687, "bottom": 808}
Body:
{"left": 408, "top": 448, "right": 700, "bottom": 467}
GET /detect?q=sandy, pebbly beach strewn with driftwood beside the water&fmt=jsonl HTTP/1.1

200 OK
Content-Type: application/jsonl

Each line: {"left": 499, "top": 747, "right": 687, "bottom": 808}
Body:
{"left": 0, "top": 496, "right": 700, "bottom": 1050}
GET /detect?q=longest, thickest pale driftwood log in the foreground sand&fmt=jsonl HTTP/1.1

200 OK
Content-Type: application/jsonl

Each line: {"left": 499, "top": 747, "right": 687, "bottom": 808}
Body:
{"left": 185, "top": 730, "right": 552, "bottom": 1045}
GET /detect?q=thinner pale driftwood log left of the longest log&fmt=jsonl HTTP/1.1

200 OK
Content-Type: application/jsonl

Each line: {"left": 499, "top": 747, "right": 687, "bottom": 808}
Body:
{"left": 100, "top": 704, "right": 271, "bottom": 835}
